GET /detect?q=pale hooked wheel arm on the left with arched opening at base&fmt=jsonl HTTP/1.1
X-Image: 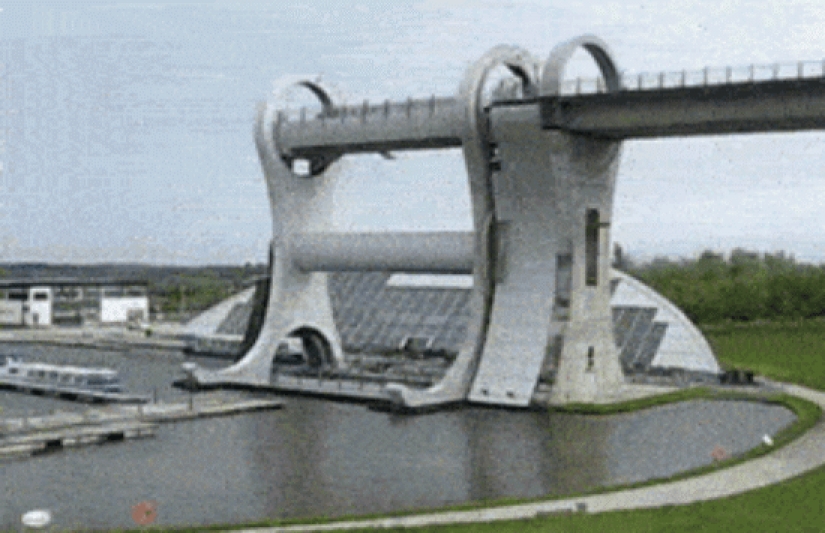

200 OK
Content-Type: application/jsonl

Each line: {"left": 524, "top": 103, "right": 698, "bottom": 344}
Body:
{"left": 193, "top": 81, "right": 343, "bottom": 385}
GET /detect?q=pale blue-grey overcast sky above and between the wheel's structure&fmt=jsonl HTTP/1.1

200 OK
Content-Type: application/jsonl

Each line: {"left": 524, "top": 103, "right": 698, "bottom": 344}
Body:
{"left": 0, "top": 0, "right": 825, "bottom": 264}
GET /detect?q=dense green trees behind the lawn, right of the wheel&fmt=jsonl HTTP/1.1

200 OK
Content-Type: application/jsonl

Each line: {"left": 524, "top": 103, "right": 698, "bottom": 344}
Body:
{"left": 614, "top": 246, "right": 825, "bottom": 324}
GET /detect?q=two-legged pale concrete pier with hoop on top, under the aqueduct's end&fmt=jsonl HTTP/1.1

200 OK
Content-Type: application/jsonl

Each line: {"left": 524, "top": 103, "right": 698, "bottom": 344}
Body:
{"left": 469, "top": 36, "right": 623, "bottom": 406}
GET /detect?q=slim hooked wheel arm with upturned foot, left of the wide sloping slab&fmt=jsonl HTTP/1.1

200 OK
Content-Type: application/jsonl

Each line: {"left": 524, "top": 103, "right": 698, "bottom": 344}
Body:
{"left": 386, "top": 45, "right": 536, "bottom": 408}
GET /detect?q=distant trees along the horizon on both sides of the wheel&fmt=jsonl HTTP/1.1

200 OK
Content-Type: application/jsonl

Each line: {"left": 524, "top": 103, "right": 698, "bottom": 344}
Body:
{"left": 9, "top": 245, "right": 825, "bottom": 324}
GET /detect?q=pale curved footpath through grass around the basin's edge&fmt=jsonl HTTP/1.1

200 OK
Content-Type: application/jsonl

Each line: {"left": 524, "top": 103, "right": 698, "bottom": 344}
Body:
{"left": 230, "top": 383, "right": 825, "bottom": 533}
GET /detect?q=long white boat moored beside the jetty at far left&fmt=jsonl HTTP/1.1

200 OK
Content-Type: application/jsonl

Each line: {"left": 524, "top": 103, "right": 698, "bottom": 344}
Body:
{"left": 0, "top": 355, "right": 123, "bottom": 393}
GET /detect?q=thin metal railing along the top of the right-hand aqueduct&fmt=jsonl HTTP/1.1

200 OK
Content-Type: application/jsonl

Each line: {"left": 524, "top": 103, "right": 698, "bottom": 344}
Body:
{"left": 561, "top": 60, "right": 825, "bottom": 96}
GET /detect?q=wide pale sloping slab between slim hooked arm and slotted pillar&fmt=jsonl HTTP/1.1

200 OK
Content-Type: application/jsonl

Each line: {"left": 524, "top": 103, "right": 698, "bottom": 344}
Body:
{"left": 469, "top": 106, "right": 559, "bottom": 406}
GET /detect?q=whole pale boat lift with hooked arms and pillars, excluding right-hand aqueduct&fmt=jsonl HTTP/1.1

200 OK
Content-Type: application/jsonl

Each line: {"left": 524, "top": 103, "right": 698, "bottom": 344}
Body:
{"left": 187, "top": 36, "right": 718, "bottom": 409}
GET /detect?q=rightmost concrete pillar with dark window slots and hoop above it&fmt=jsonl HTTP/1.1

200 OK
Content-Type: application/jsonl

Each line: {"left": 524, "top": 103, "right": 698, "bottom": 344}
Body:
{"left": 541, "top": 35, "right": 624, "bottom": 402}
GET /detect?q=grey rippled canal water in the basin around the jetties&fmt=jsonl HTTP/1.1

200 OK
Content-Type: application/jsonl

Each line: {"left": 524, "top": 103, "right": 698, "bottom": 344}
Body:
{"left": 0, "top": 344, "right": 794, "bottom": 530}
